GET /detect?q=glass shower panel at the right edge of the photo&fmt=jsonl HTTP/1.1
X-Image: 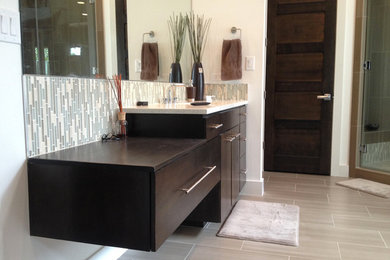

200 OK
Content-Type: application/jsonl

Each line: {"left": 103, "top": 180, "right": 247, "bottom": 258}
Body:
{"left": 360, "top": 0, "right": 390, "bottom": 175}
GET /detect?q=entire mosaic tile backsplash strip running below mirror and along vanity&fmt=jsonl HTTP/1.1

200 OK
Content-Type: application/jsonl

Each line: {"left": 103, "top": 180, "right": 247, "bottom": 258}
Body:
{"left": 23, "top": 75, "right": 248, "bottom": 157}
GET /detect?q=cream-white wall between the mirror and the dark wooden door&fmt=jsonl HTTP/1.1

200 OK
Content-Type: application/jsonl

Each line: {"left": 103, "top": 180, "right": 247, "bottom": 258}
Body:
{"left": 192, "top": 0, "right": 267, "bottom": 187}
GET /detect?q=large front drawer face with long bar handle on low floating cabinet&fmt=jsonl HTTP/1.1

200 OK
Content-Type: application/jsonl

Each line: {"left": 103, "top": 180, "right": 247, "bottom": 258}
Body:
{"left": 152, "top": 138, "right": 221, "bottom": 250}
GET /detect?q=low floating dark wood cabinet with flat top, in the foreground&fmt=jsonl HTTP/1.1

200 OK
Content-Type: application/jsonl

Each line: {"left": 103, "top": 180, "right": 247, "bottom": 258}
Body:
{"left": 28, "top": 138, "right": 221, "bottom": 251}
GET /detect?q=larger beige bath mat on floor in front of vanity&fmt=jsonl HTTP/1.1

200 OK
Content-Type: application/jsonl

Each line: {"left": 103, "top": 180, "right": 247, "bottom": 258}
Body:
{"left": 217, "top": 200, "right": 299, "bottom": 246}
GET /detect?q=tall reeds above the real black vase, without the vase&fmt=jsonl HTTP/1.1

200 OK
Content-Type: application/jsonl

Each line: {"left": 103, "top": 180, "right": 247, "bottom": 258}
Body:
{"left": 185, "top": 12, "right": 211, "bottom": 63}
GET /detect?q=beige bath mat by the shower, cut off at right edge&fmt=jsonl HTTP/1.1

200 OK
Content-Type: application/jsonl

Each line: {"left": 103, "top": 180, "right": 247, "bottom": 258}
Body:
{"left": 336, "top": 178, "right": 390, "bottom": 198}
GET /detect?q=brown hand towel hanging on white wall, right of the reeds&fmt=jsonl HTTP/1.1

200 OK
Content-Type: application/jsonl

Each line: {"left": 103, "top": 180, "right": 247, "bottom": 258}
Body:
{"left": 221, "top": 39, "right": 242, "bottom": 80}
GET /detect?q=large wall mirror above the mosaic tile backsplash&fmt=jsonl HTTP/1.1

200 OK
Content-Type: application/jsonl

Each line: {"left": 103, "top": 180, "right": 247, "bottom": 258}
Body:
{"left": 21, "top": 0, "right": 192, "bottom": 82}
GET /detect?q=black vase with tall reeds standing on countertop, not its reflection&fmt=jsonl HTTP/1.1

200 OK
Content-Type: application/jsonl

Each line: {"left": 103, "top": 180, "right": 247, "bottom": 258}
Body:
{"left": 186, "top": 12, "right": 211, "bottom": 101}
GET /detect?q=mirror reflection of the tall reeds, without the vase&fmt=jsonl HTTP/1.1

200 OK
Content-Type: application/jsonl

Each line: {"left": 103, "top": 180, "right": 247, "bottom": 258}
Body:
{"left": 168, "top": 13, "right": 187, "bottom": 63}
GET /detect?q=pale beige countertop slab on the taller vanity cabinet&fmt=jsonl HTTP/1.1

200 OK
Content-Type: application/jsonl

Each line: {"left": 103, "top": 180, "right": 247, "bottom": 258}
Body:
{"left": 123, "top": 100, "right": 248, "bottom": 115}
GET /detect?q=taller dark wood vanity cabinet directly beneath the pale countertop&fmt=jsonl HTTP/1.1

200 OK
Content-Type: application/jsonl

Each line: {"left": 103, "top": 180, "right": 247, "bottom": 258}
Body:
{"left": 126, "top": 106, "right": 247, "bottom": 222}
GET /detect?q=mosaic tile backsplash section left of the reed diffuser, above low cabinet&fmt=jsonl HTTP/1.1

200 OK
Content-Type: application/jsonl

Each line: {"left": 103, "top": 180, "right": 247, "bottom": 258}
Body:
{"left": 23, "top": 76, "right": 115, "bottom": 157}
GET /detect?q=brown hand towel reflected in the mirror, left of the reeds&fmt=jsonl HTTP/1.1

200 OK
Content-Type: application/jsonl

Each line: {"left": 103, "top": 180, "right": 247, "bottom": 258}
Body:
{"left": 141, "top": 42, "right": 159, "bottom": 80}
